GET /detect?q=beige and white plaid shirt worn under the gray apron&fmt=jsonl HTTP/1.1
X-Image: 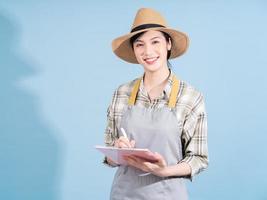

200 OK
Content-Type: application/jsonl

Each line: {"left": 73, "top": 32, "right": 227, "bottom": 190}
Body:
{"left": 105, "top": 70, "right": 208, "bottom": 180}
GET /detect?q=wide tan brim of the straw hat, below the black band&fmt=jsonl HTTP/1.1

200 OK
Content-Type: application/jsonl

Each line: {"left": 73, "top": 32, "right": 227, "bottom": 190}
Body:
{"left": 112, "top": 27, "right": 189, "bottom": 64}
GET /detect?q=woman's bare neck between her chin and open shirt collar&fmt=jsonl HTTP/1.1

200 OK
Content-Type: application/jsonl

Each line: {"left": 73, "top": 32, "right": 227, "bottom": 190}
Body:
{"left": 144, "top": 66, "right": 170, "bottom": 88}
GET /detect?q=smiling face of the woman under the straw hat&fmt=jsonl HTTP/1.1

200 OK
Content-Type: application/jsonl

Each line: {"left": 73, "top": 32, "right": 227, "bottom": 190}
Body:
{"left": 133, "top": 30, "right": 171, "bottom": 72}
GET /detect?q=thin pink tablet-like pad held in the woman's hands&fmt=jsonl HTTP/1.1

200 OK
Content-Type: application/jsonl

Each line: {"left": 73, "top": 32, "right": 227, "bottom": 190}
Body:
{"left": 95, "top": 146, "right": 158, "bottom": 165}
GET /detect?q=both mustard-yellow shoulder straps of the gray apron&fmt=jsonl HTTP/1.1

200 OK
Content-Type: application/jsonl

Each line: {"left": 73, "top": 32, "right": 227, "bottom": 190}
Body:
{"left": 128, "top": 75, "right": 180, "bottom": 108}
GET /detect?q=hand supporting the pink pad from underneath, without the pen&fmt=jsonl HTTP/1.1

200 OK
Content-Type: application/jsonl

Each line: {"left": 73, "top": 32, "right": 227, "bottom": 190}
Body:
{"left": 125, "top": 153, "right": 167, "bottom": 177}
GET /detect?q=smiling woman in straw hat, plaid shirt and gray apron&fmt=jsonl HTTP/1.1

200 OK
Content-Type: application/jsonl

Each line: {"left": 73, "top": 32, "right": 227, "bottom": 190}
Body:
{"left": 104, "top": 8, "right": 208, "bottom": 200}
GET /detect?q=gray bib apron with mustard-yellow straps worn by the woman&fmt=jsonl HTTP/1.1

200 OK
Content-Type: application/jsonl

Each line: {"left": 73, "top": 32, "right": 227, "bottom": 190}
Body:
{"left": 110, "top": 75, "right": 187, "bottom": 200}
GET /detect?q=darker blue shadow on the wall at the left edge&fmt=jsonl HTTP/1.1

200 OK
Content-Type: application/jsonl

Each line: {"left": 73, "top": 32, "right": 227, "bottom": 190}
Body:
{"left": 0, "top": 11, "right": 60, "bottom": 200}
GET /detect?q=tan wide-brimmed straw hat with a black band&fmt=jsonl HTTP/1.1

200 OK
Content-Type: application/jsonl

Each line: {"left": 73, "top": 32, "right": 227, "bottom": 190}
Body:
{"left": 112, "top": 8, "right": 189, "bottom": 63}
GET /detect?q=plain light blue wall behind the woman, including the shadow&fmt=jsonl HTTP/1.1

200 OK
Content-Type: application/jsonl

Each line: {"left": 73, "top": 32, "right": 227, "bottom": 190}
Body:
{"left": 0, "top": 0, "right": 267, "bottom": 200}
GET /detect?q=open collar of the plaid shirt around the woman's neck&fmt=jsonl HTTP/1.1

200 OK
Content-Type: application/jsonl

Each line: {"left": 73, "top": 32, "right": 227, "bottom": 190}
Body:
{"left": 139, "top": 68, "right": 174, "bottom": 99}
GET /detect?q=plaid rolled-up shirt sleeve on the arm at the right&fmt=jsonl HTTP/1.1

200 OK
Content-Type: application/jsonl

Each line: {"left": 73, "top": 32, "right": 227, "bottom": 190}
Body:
{"left": 180, "top": 95, "right": 209, "bottom": 181}
